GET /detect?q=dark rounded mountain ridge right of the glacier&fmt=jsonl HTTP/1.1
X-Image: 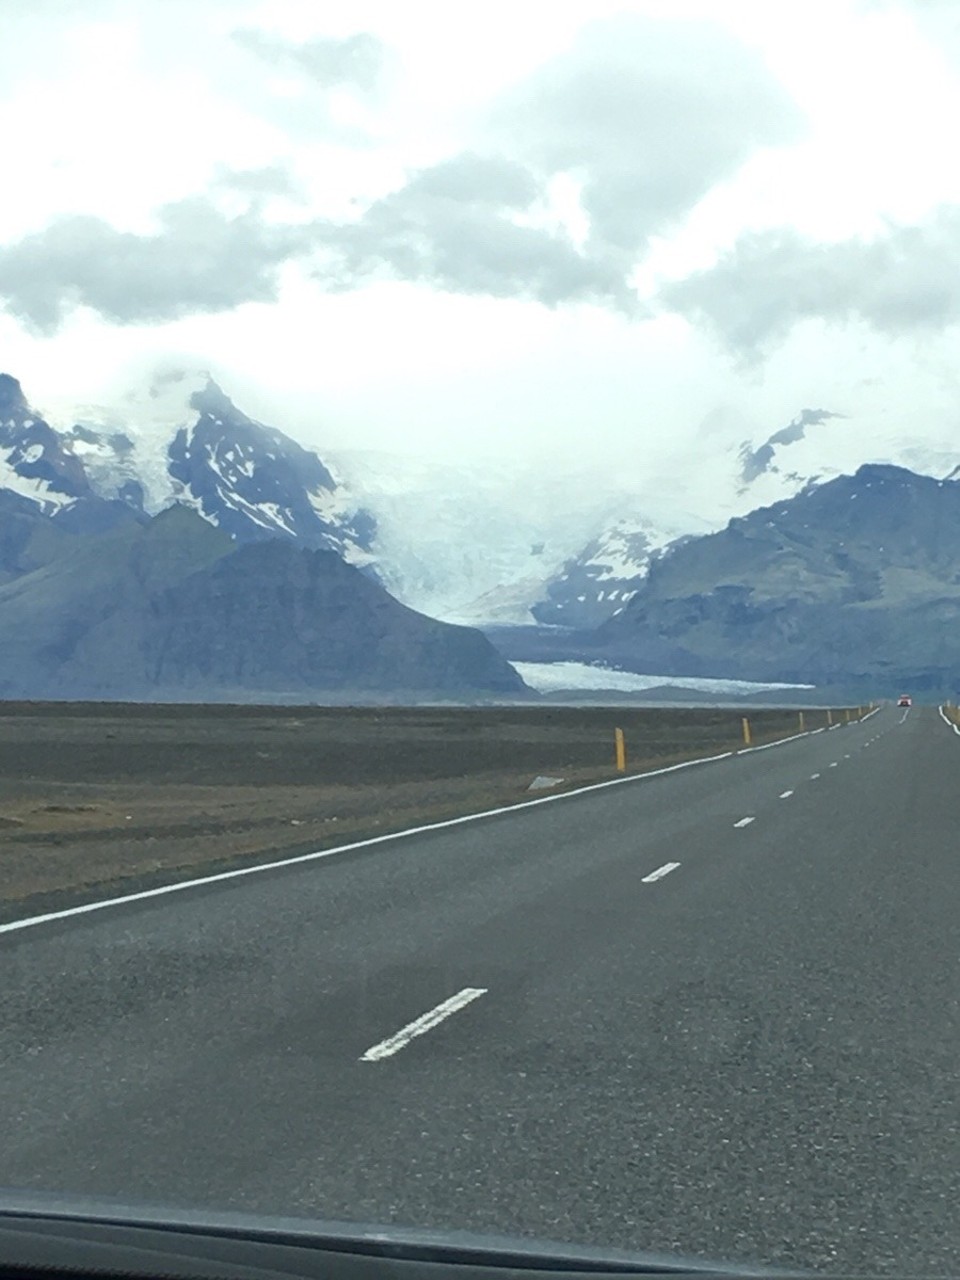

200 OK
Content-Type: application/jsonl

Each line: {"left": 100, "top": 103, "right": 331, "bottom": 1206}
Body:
{"left": 591, "top": 466, "right": 960, "bottom": 687}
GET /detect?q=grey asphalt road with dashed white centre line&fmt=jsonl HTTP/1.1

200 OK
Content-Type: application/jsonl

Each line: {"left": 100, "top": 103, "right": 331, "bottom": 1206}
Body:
{"left": 0, "top": 708, "right": 960, "bottom": 1275}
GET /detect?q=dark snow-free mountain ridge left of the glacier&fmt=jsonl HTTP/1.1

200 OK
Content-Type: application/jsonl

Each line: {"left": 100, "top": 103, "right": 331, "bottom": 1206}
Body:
{"left": 0, "top": 507, "right": 529, "bottom": 701}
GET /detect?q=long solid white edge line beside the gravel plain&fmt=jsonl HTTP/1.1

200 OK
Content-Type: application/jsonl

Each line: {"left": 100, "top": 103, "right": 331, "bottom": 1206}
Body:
{"left": 0, "top": 712, "right": 873, "bottom": 936}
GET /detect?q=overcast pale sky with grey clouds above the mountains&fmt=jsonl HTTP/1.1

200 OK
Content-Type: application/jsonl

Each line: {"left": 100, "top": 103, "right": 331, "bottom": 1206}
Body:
{"left": 0, "top": 0, "right": 960, "bottom": 494}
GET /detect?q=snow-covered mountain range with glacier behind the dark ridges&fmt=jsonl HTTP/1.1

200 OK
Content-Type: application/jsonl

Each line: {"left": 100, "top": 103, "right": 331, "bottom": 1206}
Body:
{"left": 15, "top": 370, "right": 960, "bottom": 640}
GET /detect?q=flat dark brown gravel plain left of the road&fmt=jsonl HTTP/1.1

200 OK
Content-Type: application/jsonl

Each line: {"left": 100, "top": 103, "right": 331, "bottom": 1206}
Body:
{"left": 0, "top": 703, "right": 836, "bottom": 919}
